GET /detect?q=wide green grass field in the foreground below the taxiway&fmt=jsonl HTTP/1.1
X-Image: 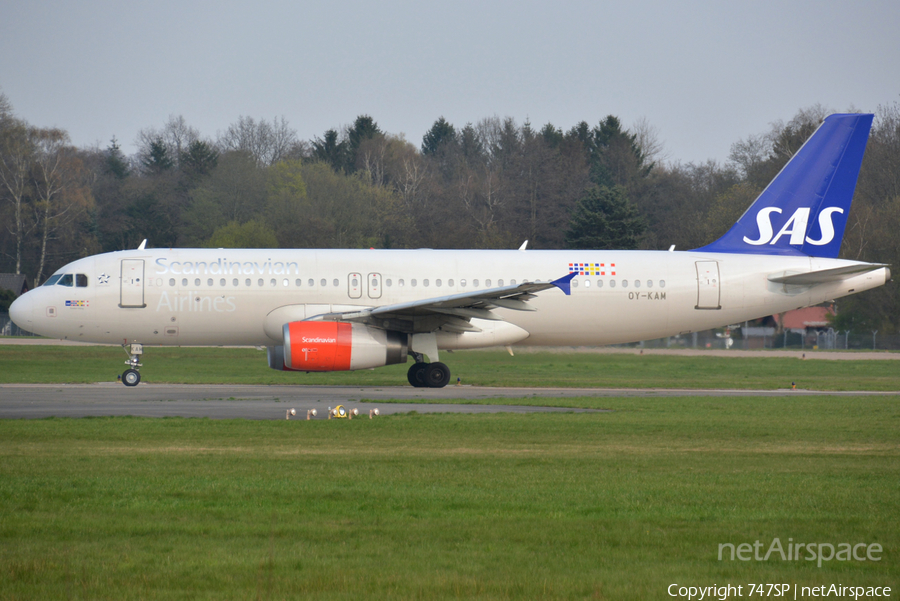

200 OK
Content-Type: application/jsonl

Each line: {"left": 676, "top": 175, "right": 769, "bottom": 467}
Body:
{"left": 0, "top": 394, "right": 900, "bottom": 599}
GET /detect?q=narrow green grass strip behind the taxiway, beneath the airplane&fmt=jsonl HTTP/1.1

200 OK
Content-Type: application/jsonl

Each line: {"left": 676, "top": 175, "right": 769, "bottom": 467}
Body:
{"left": 0, "top": 345, "right": 900, "bottom": 390}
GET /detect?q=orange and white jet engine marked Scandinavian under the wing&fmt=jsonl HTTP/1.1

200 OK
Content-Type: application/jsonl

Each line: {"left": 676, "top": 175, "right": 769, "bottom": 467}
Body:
{"left": 268, "top": 321, "right": 408, "bottom": 371}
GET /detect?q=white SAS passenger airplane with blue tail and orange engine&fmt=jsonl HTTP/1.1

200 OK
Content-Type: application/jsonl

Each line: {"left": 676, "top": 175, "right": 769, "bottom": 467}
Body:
{"left": 10, "top": 114, "right": 891, "bottom": 388}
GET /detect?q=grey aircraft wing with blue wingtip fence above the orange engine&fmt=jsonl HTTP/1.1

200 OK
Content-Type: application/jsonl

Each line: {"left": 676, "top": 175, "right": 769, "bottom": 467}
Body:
{"left": 306, "top": 273, "right": 577, "bottom": 333}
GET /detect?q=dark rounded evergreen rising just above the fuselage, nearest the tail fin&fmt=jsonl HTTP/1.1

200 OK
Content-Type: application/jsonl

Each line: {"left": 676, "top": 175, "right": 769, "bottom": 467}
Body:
{"left": 566, "top": 186, "right": 646, "bottom": 250}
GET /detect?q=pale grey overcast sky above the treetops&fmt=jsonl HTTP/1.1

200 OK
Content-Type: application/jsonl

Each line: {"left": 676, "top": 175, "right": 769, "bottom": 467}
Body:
{"left": 0, "top": 0, "right": 900, "bottom": 162}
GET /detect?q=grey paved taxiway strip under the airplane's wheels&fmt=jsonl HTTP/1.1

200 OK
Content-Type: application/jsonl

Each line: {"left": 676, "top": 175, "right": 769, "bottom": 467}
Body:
{"left": 0, "top": 383, "right": 897, "bottom": 419}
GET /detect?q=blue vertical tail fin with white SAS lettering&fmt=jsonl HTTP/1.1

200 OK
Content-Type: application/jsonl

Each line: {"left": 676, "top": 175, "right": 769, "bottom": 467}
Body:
{"left": 697, "top": 114, "right": 873, "bottom": 258}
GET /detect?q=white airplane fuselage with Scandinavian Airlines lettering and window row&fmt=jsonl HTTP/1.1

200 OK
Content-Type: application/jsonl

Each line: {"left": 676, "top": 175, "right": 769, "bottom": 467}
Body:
{"left": 14, "top": 249, "right": 890, "bottom": 348}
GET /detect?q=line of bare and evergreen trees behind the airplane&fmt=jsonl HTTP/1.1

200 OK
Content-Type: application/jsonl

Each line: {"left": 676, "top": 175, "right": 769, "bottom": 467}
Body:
{"left": 0, "top": 93, "right": 900, "bottom": 333}
